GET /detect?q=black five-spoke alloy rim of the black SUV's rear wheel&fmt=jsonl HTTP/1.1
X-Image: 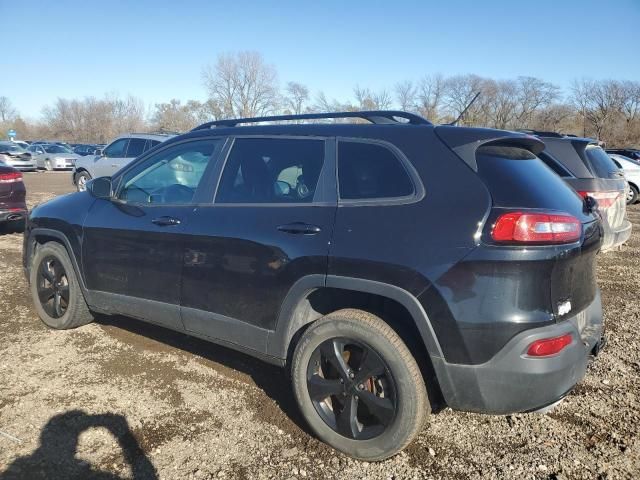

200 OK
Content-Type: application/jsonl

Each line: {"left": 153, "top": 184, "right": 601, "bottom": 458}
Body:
{"left": 307, "top": 338, "right": 397, "bottom": 440}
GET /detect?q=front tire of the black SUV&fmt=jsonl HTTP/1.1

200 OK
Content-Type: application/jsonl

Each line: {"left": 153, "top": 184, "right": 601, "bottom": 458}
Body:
{"left": 29, "top": 242, "right": 93, "bottom": 330}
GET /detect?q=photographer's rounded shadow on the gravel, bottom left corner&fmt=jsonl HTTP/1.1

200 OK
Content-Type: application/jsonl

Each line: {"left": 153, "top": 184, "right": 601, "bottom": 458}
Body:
{"left": 0, "top": 410, "right": 158, "bottom": 480}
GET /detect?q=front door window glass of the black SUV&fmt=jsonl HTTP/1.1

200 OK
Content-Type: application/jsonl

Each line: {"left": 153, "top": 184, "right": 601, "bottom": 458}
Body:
{"left": 118, "top": 140, "right": 220, "bottom": 205}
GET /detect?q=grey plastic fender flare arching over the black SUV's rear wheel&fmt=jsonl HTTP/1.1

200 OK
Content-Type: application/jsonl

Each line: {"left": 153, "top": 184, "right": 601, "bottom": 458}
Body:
{"left": 267, "top": 274, "right": 443, "bottom": 359}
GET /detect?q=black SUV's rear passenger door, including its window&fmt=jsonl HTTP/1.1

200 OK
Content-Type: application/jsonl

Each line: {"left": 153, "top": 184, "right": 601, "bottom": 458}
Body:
{"left": 182, "top": 137, "right": 336, "bottom": 351}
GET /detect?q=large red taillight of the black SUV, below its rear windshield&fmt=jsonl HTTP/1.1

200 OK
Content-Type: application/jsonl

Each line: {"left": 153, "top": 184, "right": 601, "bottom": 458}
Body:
{"left": 491, "top": 212, "right": 582, "bottom": 243}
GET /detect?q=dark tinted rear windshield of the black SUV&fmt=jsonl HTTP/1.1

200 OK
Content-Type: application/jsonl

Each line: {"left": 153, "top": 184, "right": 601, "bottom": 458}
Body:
{"left": 476, "top": 145, "right": 583, "bottom": 218}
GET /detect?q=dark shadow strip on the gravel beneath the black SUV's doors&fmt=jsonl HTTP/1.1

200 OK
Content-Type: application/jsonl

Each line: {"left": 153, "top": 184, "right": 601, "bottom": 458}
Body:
{"left": 96, "top": 315, "right": 315, "bottom": 437}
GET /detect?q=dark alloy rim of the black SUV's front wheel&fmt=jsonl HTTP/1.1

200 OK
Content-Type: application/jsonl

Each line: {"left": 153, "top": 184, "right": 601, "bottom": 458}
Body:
{"left": 37, "top": 256, "right": 69, "bottom": 318}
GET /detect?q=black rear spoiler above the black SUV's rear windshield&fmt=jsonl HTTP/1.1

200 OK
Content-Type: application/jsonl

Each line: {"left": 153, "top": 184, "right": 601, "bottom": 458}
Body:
{"left": 434, "top": 125, "right": 544, "bottom": 172}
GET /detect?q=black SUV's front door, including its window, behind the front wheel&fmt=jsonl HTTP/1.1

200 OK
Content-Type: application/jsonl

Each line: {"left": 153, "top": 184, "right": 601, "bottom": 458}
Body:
{"left": 82, "top": 139, "right": 222, "bottom": 328}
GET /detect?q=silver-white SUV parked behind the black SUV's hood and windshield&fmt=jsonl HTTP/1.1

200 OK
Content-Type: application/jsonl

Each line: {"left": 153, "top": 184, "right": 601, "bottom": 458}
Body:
{"left": 73, "top": 133, "right": 174, "bottom": 192}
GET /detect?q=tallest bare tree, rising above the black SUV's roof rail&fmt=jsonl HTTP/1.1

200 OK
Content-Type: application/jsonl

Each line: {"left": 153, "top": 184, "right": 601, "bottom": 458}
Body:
{"left": 202, "top": 51, "right": 279, "bottom": 118}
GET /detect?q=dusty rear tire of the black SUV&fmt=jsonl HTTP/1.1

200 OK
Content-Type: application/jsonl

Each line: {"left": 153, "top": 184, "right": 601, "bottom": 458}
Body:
{"left": 291, "top": 309, "right": 431, "bottom": 461}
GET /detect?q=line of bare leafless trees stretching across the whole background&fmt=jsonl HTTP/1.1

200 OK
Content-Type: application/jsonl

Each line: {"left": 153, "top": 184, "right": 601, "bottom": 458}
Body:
{"left": 0, "top": 51, "right": 640, "bottom": 146}
